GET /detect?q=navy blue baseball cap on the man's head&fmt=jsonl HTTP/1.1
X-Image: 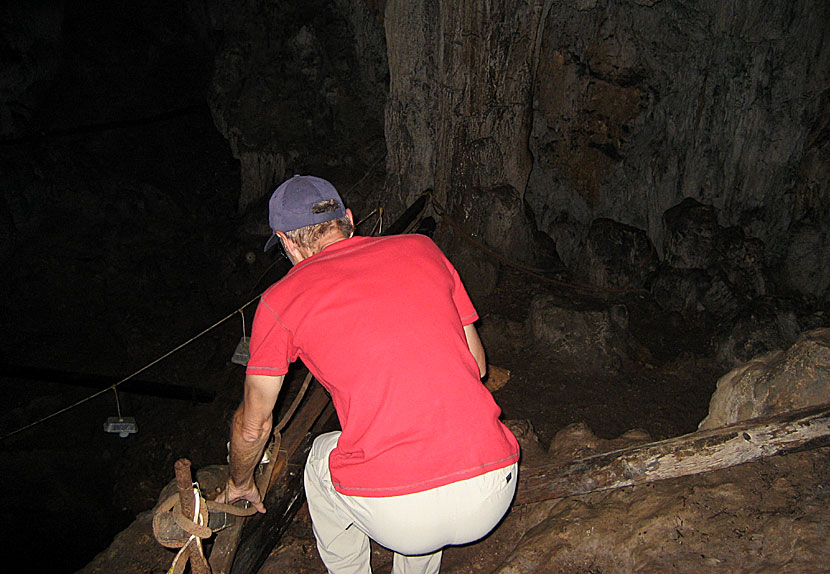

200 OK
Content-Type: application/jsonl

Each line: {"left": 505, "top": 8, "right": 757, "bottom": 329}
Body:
{"left": 265, "top": 175, "right": 346, "bottom": 251}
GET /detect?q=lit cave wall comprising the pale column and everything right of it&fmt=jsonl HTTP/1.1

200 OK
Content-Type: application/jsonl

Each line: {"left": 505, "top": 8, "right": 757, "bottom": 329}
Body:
{"left": 385, "top": 0, "right": 830, "bottom": 302}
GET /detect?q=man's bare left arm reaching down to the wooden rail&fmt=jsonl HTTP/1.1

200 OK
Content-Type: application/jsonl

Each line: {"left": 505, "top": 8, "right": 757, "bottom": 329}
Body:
{"left": 226, "top": 375, "right": 285, "bottom": 512}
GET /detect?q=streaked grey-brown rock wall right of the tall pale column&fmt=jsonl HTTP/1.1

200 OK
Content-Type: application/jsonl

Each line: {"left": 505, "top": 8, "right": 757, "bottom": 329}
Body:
{"left": 526, "top": 0, "right": 830, "bottom": 262}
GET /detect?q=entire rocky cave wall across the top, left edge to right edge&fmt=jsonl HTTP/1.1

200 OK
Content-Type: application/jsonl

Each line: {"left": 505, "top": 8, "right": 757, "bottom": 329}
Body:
{"left": 0, "top": 0, "right": 830, "bottom": 299}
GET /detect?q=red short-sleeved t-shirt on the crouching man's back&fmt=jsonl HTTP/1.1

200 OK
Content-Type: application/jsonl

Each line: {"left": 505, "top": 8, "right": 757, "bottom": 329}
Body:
{"left": 247, "top": 235, "right": 519, "bottom": 496}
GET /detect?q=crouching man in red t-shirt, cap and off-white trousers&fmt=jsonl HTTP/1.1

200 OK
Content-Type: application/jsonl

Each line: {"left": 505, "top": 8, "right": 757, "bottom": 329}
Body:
{"left": 227, "top": 176, "right": 519, "bottom": 574}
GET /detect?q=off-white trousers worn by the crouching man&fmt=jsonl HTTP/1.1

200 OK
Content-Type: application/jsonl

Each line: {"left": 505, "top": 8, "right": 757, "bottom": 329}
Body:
{"left": 305, "top": 431, "right": 518, "bottom": 574}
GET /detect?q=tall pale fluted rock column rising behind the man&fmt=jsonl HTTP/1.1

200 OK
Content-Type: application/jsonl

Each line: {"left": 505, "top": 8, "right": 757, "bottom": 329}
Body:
{"left": 385, "top": 0, "right": 541, "bottom": 286}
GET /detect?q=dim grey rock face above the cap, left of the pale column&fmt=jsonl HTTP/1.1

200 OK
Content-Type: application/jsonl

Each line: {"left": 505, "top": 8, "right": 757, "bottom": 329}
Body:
{"left": 208, "top": 0, "right": 387, "bottom": 211}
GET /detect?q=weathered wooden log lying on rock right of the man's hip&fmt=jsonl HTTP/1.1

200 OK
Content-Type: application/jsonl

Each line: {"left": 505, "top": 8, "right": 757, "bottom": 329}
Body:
{"left": 515, "top": 404, "right": 830, "bottom": 505}
